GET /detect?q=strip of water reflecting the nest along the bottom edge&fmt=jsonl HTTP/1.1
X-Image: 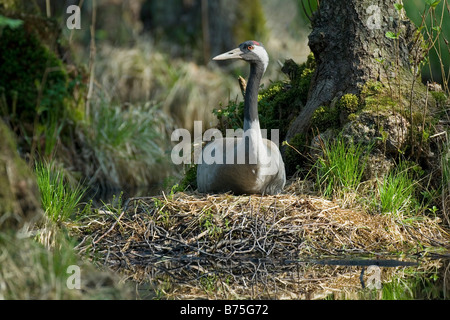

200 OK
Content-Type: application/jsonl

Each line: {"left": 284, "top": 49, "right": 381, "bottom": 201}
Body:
{"left": 111, "top": 252, "right": 450, "bottom": 300}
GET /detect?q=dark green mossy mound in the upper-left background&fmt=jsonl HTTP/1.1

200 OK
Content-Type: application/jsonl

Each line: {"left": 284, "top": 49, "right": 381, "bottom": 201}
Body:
{"left": 0, "top": 14, "right": 86, "bottom": 157}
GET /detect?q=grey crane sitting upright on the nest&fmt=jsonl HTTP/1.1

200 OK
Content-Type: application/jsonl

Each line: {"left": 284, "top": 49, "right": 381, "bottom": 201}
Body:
{"left": 197, "top": 41, "right": 286, "bottom": 194}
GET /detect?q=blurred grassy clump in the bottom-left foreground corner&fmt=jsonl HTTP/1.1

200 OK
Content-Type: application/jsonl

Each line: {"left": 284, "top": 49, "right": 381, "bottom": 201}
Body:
{"left": 0, "top": 231, "right": 132, "bottom": 300}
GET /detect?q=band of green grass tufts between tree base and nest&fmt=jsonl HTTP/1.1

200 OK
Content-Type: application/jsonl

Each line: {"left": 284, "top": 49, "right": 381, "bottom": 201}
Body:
{"left": 310, "top": 135, "right": 442, "bottom": 222}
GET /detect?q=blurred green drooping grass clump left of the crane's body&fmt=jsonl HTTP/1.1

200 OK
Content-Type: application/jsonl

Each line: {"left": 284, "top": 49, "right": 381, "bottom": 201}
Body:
{"left": 84, "top": 99, "right": 173, "bottom": 188}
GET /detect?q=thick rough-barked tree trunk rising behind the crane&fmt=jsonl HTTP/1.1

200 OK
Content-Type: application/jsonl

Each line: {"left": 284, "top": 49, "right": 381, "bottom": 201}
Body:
{"left": 286, "top": 0, "right": 414, "bottom": 141}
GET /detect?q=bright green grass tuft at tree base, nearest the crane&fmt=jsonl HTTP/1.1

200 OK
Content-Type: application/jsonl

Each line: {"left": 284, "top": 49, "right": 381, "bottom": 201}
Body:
{"left": 314, "top": 136, "right": 368, "bottom": 197}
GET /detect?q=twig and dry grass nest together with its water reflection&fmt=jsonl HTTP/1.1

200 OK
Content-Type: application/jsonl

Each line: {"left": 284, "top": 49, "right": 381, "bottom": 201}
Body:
{"left": 74, "top": 189, "right": 449, "bottom": 299}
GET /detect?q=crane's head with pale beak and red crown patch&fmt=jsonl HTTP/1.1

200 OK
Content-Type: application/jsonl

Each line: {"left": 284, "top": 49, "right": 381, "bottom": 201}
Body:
{"left": 213, "top": 40, "right": 269, "bottom": 71}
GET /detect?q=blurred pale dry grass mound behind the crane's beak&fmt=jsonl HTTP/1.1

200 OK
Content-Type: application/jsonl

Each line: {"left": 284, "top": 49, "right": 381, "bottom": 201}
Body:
{"left": 97, "top": 38, "right": 239, "bottom": 130}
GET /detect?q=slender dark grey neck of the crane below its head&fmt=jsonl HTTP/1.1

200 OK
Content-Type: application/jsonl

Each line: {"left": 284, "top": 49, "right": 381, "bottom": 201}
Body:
{"left": 244, "top": 63, "right": 265, "bottom": 135}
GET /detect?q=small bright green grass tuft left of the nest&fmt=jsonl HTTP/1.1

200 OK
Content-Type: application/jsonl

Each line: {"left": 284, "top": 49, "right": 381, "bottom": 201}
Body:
{"left": 36, "top": 163, "right": 86, "bottom": 222}
